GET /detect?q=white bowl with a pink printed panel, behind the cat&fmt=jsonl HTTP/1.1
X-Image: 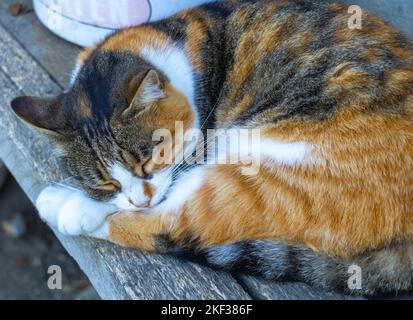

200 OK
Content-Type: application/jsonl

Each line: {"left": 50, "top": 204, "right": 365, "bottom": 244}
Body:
{"left": 33, "top": 0, "right": 213, "bottom": 47}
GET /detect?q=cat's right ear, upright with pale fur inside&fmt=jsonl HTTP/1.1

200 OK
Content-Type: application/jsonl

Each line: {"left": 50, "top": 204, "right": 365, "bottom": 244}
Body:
{"left": 123, "top": 70, "right": 165, "bottom": 116}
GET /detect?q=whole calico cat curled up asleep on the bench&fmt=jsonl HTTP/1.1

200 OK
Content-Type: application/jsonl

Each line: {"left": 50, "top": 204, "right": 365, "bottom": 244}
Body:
{"left": 8, "top": 0, "right": 413, "bottom": 295}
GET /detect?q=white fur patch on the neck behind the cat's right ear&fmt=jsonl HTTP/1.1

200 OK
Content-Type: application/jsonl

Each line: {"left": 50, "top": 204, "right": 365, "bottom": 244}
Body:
{"left": 140, "top": 44, "right": 199, "bottom": 128}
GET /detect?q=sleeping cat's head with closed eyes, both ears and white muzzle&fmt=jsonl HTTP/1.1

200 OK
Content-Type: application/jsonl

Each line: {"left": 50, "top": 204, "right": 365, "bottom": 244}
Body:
{"left": 12, "top": 51, "right": 195, "bottom": 210}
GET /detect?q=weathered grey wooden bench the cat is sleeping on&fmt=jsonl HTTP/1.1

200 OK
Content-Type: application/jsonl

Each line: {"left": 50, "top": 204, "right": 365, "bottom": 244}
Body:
{"left": 0, "top": 0, "right": 410, "bottom": 300}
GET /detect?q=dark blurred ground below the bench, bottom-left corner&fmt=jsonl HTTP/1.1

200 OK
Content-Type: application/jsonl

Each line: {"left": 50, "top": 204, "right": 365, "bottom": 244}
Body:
{"left": 0, "top": 176, "right": 96, "bottom": 299}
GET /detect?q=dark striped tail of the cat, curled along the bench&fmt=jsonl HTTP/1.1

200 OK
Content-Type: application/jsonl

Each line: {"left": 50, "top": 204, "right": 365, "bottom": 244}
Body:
{"left": 199, "top": 241, "right": 413, "bottom": 296}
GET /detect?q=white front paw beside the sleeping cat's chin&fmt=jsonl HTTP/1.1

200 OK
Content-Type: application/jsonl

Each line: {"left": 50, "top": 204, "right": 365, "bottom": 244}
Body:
{"left": 36, "top": 187, "right": 117, "bottom": 238}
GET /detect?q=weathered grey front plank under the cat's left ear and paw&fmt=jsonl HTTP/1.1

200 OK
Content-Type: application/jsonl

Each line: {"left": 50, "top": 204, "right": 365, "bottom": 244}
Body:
{"left": 0, "top": 23, "right": 250, "bottom": 299}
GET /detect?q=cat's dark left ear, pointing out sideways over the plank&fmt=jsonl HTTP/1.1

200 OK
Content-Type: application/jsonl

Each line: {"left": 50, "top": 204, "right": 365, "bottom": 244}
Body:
{"left": 11, "top": 97, "right": 67, "bottom": 133}
